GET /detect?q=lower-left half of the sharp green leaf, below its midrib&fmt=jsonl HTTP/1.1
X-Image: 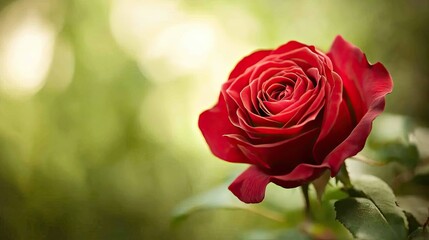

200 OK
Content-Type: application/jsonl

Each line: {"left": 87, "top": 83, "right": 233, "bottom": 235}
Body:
{"left": 335, "top": 198, "right": 400, "bottom": 240}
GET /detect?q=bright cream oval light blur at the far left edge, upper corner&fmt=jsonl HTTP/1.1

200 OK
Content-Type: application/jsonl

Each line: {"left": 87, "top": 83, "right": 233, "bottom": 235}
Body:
{"left": 0, "top": 2, "right": 55, "bottom": 96}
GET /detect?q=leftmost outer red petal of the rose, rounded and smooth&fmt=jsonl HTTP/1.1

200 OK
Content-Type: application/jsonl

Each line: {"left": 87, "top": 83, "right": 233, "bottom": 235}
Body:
{"left": 198, "top": 94, "right": 248, "bottom": 163}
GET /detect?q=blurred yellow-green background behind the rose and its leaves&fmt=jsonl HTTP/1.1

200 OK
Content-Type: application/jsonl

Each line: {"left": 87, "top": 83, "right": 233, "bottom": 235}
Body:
{"left": 0, "top": 0, "right": 429, "bottom": 239}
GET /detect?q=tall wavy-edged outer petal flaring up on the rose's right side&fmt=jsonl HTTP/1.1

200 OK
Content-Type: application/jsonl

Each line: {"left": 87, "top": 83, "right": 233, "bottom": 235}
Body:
{"left": 324, "top": 36, "right": 393, "bottom": 176}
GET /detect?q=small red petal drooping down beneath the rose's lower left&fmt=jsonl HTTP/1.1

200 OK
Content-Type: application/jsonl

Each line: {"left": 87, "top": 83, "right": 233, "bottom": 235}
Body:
{"left": 228, "top": 166, "right": 270, "bottom": 203}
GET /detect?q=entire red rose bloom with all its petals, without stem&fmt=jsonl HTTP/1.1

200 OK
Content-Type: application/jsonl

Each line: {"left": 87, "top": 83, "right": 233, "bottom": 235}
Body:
{"left": 198, "top": 36, "right": 393, "bottom": 203}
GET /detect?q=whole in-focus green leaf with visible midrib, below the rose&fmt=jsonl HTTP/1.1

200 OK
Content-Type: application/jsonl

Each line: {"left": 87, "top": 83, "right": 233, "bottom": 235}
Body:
{"left": 335, "top": 176, "right": 408, "bottom": 239}
